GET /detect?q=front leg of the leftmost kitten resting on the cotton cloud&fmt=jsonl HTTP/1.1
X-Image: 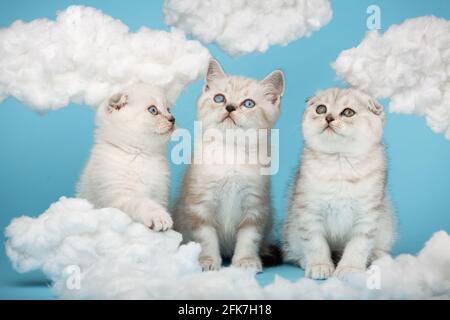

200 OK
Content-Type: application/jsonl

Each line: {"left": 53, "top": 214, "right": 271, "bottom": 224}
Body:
{"left": 112, "top": 197, "right": 173, "bottom": 231}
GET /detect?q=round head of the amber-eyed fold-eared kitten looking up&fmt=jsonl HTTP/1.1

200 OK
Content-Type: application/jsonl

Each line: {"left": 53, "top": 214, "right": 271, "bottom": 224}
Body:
{"left": 303, "top": 88, "right": 384, "bottom": 154}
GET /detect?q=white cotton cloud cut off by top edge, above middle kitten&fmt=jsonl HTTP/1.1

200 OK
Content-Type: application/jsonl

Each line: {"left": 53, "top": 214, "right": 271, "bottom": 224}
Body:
{"left": 164, "top": 0, "right": 332, "bottom": 56}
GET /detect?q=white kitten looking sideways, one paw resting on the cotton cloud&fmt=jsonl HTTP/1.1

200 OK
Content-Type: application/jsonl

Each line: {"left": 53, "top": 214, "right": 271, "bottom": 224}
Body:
{"left": 77, "top": 84, "right": 175, "bottom": 231}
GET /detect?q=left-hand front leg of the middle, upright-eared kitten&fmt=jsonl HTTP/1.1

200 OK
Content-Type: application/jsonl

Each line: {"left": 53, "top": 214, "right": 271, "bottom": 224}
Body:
{"left": 192, "top": 224, "right": 222, "bottom": 271}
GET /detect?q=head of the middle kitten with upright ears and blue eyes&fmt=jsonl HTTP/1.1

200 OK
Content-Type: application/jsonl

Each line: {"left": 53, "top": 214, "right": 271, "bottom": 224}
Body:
{"left": 198, "top": 60, "right": 284, "bottom": 130}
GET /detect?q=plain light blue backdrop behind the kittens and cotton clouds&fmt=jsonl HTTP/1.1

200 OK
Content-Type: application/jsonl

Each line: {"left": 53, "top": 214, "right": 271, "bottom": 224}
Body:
{"left": 0, "top": 0, "right": 450, "bottom": 299}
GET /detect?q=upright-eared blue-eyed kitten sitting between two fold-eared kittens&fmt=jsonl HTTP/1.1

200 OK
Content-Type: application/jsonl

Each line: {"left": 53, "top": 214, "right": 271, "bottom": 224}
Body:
{"left": 174, "top": 60, "right": 284, "bottom": 271}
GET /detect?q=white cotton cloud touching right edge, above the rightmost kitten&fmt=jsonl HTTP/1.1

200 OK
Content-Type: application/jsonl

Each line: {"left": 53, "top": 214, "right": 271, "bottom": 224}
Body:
{"left": 333, "top": 16, "right": 450, "bottom": 139}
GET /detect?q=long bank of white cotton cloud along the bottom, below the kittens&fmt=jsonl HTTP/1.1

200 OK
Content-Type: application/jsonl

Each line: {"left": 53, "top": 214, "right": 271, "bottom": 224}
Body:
{"left": 5, "top": 198, "right": 450, "bottom": 299}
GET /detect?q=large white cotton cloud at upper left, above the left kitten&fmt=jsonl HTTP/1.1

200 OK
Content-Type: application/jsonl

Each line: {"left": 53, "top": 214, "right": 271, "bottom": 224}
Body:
{"left": 0, "top": 6, "right": 209, "bottom": 111}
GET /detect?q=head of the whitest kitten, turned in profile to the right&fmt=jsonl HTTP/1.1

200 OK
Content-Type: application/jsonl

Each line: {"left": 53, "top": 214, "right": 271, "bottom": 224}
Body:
{"left": 98, "top": 85, "right": 175, "bottom": 139}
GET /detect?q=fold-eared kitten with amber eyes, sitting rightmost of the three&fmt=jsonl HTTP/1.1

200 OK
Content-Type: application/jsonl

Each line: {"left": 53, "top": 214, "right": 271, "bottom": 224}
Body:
{"left": 284, "top": 88, "right": 394, "bottom": 279}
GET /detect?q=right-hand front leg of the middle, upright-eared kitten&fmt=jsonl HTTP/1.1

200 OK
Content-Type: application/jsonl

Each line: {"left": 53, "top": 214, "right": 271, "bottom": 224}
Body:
{"left": 231, "top": 221, "right": 262, "bottom": 271}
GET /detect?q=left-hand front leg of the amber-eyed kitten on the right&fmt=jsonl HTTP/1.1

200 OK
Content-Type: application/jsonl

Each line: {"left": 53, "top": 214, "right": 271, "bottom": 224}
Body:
{"left": 286, "top": 206, "right": 334, "bottom": 279}
